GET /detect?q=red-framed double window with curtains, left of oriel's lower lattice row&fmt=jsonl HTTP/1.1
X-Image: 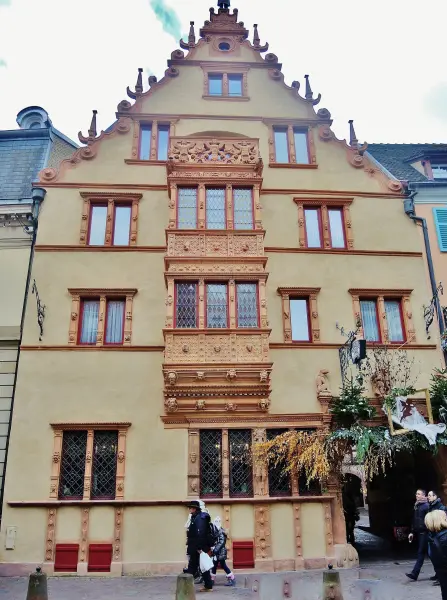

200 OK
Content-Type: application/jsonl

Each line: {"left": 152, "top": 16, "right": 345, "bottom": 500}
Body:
{"left": 79, "top": 298, "right": 125, "bottom": 345}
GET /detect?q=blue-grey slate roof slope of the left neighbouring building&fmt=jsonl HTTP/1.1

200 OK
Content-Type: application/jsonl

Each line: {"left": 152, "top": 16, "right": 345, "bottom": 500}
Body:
{"left": 0, "top": 129, "right": 51, "bottom": 202}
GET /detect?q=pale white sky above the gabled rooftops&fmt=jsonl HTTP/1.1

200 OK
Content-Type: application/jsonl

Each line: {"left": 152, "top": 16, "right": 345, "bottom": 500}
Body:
{"left": 0, "top": 0, "right": 447, "bottom": 143}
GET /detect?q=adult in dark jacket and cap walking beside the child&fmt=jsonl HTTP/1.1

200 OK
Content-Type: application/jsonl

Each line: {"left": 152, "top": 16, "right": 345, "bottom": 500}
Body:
{"left": 186, "top": 500, "right": 213, "bottom": 591}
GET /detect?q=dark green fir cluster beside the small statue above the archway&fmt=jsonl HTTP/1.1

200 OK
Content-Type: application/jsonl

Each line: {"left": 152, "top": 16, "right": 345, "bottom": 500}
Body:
{"left": 329, "top": 376, "right": 376, "bottom": 427}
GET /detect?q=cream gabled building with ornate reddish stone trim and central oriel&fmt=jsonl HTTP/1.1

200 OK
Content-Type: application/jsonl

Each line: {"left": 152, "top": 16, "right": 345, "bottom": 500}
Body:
{"left": 0, "top": 1, "right": 439, "bottom": 575}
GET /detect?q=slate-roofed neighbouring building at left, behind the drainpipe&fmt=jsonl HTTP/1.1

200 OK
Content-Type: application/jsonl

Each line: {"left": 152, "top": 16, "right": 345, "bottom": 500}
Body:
{"left": 0, "top": 106, "right": 77, "bottom": 518}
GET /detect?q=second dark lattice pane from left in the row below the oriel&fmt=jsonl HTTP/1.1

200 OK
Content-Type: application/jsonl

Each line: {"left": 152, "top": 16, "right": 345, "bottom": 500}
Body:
{"left": 228, "top": 429, "right": 253, "bottom": 498}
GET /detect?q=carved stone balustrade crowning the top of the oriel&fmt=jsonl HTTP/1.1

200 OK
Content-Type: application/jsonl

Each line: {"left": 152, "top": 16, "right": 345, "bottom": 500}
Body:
{"left": 168, "top": 137, "right": 259, "bottom": 165}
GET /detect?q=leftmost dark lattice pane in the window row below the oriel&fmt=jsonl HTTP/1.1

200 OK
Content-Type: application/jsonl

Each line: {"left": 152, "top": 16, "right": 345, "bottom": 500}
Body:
{"left": 200, "top": 429, "right": 222, "bottom": 498}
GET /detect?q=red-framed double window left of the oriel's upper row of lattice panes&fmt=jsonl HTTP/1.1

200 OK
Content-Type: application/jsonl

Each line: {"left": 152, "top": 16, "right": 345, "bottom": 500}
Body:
{"left": 88, "top": 204, "right": 132, "bottom": 246}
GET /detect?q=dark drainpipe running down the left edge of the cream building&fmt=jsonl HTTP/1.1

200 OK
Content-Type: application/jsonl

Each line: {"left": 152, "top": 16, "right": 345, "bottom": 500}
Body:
{"left": 0, "top": 187, "right": 47, "bottom": 523}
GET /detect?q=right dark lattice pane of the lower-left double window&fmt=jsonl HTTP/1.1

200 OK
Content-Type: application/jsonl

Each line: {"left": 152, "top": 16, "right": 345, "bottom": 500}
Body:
{"left": 91, "top": 431, "right": 118, "bottom": 499}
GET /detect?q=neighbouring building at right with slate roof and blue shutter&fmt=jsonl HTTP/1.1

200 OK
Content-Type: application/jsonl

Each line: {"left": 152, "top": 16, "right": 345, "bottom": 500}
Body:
{"left": 368, "top": 144, "right": 447, "bottom": 348}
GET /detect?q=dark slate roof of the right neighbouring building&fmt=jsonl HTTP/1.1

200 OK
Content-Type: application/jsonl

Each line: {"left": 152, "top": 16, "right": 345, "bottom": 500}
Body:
{"left": 367, "top": 144, "right": 447, "bottom": 182}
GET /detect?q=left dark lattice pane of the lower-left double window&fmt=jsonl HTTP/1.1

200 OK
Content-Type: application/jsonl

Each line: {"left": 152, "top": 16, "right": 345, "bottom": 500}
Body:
{"left": 59, "top": 431, "right": 87, "bottom": 500}
